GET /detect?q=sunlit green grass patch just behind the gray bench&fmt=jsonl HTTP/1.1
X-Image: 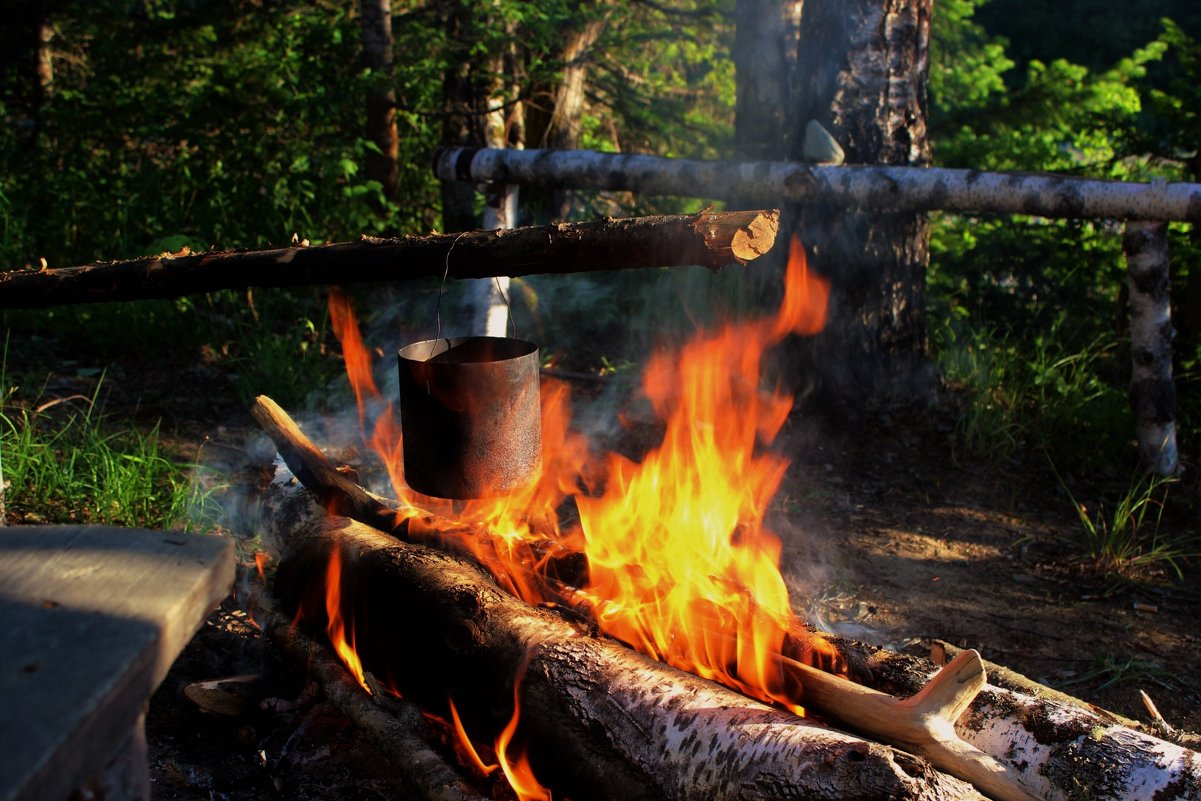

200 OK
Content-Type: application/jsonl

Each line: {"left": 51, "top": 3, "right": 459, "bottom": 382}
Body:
{"left": 0, "top": 382, "right": 219, "bottom": 530}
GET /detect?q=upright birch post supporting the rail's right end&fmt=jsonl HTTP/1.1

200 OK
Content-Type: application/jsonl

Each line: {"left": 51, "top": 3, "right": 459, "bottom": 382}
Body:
{"left": 1122, "top": 220, "right": 1179, "bottom": 476}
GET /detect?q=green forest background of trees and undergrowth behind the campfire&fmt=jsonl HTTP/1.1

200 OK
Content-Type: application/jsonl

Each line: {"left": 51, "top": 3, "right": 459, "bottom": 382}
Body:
{"left": 0, "top": 0, "right": 1201, "bottom": 575}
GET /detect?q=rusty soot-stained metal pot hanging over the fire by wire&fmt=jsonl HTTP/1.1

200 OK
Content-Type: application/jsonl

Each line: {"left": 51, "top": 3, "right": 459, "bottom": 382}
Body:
{"left": 396, "top": 336, "right": 542, "bottom": 498}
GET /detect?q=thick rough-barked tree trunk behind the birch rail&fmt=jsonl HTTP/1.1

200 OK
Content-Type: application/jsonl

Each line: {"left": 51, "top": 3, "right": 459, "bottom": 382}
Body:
{"left": 791, "top": 0, "right": 932, "bottom": 410}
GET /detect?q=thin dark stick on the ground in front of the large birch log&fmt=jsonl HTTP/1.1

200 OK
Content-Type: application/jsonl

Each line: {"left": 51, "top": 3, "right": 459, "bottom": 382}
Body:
{"left": 255, "top": 594, "right": 485, "bottom": 801}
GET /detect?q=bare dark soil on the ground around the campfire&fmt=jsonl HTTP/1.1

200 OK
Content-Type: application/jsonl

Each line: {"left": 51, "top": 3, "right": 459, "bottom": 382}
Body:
{"left": 4, "top": 353, "right": 1201, "bottom": 801}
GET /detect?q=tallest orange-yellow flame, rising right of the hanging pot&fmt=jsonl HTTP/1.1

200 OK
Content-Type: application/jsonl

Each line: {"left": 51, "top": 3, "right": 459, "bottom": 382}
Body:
{"left": 576, "top": 239, "right": 829, "bottom": 711}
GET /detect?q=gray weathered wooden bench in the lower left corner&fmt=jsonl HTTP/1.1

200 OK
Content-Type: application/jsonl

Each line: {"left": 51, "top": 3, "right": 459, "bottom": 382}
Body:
{"left": 0, "top": 526, "right": 234, "bottom": 801}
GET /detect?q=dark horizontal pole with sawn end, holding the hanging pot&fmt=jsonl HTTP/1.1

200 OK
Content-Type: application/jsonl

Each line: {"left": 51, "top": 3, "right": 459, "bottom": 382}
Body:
{"left": 0, "top": 211, "right": 779, "bottom": 309}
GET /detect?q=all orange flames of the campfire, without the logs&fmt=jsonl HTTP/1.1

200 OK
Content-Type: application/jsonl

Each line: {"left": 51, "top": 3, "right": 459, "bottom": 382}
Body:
{"left": 330, "top": 238, "right": 830, "bottom": 782}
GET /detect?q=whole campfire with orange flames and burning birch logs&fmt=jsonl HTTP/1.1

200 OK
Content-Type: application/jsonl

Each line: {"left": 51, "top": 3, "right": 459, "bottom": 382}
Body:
{"left": 248, "top": 230, "right": 1197, "bottom": 800}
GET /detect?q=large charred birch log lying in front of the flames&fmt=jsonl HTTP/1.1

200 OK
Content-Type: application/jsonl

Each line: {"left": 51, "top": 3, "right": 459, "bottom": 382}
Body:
{"left": 264, "top": 480, "right": 981, "bottom": 801}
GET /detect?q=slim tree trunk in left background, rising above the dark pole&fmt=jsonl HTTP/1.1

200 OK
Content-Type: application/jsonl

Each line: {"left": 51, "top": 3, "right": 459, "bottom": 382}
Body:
{"left": 359, "top": 0, "right": 400, "bottom": 201}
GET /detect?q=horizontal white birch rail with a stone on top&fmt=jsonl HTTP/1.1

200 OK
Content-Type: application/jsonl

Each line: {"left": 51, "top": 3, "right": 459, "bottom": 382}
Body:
{"left": 434, "top": 148, "right": 1201, "bottom": 222}
